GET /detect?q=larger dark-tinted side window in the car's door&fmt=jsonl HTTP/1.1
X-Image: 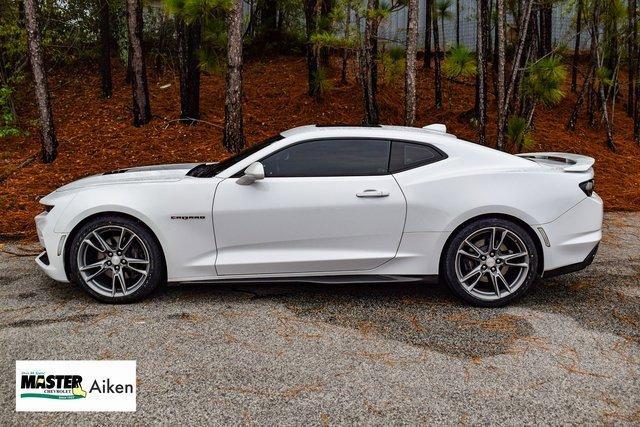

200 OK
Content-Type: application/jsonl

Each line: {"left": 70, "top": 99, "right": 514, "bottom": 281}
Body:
{"left": 262, "top": 139, "right": 391, "bottom": 178}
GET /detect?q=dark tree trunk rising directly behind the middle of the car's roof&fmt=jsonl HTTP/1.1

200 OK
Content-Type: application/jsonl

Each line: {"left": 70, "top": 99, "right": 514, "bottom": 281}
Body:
{"left": 361, "top": 0, "right": 380, "bottom": 125}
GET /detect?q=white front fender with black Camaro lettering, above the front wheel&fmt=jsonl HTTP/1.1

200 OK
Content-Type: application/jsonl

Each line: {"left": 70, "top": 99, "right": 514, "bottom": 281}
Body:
{"left": 55, "top": 179, "right": 219, "bottom": 281}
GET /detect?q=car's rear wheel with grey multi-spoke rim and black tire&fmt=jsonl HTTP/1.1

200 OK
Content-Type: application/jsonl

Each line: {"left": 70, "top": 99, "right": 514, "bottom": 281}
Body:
{"left": 444, "top": 218, "right": 538, "bottom": 307}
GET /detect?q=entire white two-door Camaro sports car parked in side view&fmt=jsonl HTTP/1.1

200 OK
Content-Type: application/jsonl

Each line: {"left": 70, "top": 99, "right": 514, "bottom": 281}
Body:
{"left": 36, "top": 125, "right": 603, "bottom": 306}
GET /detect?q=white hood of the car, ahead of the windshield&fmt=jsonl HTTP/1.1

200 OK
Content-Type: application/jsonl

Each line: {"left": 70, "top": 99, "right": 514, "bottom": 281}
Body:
{"left": 57, "top": 163, "right": 198, "bottom": 191}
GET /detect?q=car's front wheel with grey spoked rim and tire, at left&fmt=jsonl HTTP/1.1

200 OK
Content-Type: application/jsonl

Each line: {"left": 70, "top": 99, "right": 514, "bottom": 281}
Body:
{"left": 69, "top": 216, "right": 164, "bottom": 303}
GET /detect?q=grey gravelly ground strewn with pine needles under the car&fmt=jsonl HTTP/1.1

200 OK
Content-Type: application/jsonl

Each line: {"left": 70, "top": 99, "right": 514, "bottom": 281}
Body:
{"left": 0, "top": 213, "right": 640, "bottom": 425}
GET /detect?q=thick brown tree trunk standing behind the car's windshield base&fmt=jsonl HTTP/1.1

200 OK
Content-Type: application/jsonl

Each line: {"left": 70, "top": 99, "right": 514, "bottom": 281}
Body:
{"left": 222, "top": 0, "right": 244, "bottom": 153}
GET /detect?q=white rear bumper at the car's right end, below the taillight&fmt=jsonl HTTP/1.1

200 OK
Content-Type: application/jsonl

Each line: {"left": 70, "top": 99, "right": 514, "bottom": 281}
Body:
{"left": 533, "top": 193, "right": 603, "bottom": 277}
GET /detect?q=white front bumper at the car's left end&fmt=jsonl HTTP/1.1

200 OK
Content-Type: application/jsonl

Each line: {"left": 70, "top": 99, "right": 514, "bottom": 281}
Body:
{"left": 35, "top": 212, "right": 69, "bottom": 282}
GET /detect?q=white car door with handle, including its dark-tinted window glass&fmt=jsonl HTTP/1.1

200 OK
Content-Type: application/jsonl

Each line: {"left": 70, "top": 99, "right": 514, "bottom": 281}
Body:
{"left": 213, "top": 139, "right": 406, "bottom": 275}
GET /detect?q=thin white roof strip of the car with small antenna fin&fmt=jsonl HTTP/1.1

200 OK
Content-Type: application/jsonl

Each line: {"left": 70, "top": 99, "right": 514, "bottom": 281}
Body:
{"left": 281, "top": 124, "right": 457, "bottom": 139}
